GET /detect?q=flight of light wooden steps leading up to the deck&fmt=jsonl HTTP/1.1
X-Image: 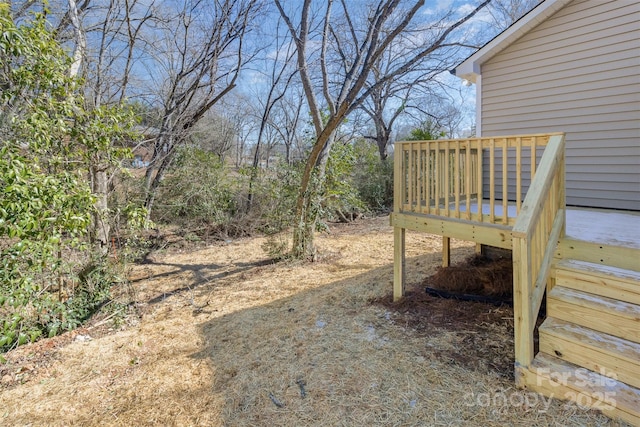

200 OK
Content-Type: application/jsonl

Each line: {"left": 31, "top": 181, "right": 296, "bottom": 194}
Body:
{"left": 526, "top": 260, "right": 640, "bottom": 425}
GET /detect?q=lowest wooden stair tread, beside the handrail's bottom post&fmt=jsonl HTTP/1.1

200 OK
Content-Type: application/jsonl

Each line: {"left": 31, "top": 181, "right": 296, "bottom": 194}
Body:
{"left": 529, "top": 353, "right": 640, "bottom": 417}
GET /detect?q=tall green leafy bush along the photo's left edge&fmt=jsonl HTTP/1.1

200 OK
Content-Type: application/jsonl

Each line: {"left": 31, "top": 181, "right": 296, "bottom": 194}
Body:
{"left": 0, "top": 8, "right": 138, "bottom": 351}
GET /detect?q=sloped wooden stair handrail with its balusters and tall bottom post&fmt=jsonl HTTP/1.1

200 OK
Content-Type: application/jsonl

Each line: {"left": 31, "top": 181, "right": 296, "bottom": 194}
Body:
{"left": 512, "top": 134, "right": 566, "bottom": 374}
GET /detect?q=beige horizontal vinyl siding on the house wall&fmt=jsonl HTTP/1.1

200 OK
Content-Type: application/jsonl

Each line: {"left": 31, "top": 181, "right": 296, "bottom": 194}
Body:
{"left": 481, "top": 0, "right": 640, "bottom": 210}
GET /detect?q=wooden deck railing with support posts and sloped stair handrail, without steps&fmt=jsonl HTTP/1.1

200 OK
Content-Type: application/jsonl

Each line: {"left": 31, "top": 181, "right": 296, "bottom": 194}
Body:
{"left": 391, "top": 133, "right": 566, "bottom": 374}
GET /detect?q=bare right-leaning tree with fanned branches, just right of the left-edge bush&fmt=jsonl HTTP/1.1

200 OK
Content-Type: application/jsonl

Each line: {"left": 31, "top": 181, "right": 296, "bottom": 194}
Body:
{"left": 139, "top": 0, "right": 259, "bottom": 219}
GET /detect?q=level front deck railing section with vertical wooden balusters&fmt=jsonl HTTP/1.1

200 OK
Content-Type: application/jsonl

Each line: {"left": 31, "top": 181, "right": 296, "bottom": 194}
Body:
{"left": 394, "top": 134, "right": 554, "bottom": 226}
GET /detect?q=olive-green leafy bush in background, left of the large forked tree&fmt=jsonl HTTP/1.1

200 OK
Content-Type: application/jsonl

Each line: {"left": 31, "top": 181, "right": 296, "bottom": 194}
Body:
{"left": 154, "top": 147, "right": 301, "bottom": 241}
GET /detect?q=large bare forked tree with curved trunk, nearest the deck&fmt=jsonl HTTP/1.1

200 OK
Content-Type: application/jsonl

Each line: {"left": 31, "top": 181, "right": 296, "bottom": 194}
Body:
{"left": 274, "top": 0, "right": 491, "bottom": 259}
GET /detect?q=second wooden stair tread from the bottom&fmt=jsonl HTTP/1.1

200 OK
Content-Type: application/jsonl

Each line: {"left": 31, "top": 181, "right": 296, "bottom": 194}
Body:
{"left": 539, "top": 317, "right": 640, "bottom": 363}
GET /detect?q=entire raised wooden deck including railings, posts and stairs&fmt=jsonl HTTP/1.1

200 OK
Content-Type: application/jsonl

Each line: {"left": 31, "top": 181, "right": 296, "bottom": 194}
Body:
{"left": 391, "top": 134, "right": 640, "bottom": 425}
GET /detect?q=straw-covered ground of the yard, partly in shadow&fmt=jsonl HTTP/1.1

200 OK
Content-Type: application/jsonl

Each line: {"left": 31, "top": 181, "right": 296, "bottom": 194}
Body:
{"left": 0, "top": 218, "right": 617, "bottom": 426}
